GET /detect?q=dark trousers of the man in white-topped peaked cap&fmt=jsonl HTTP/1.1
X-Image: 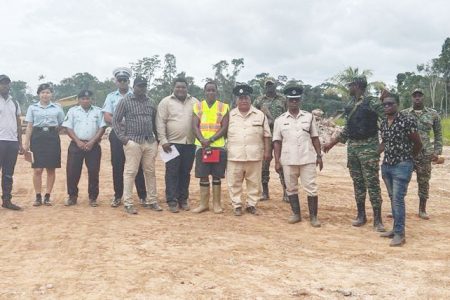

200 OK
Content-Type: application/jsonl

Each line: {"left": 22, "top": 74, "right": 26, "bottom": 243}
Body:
{"left": 109, "top": 130, "right": 147, "bottom": 199}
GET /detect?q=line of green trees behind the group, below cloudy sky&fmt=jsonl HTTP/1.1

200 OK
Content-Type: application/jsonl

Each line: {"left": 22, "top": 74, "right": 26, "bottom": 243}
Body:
{"left": 7, "top": 38, "right": 450, "bottom": 116}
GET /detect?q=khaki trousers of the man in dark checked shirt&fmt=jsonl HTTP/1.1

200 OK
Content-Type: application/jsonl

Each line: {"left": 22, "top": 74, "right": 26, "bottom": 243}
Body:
{"left": 123, "top": 140, "right": 158, "bottom": 206}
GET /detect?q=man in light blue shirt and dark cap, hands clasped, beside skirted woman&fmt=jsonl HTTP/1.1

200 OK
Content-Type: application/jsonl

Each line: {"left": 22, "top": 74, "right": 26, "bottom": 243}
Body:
{"left": 62, "top": 90, "right": 106, "bottom": 207}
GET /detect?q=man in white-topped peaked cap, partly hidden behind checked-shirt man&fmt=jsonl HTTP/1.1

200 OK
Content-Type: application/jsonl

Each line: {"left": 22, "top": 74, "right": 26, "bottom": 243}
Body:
{"left": 102, "top": 68, "right": 147, "bottom": 207}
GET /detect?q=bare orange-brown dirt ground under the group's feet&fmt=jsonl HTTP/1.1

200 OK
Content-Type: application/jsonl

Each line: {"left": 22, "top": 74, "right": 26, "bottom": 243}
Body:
{"left": 0, "top": 136, "right": 450, "bottom": 299}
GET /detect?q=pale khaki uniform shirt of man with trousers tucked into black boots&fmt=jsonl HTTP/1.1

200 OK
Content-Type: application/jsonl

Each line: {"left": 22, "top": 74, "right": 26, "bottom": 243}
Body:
{"left": 273, "top": 110, "right": 319, "bottom": 166}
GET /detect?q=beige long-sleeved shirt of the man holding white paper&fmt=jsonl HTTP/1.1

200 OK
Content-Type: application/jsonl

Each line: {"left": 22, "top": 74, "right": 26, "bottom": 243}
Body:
{"left": 156, "top": 94, "right": 198, "bottom": 145}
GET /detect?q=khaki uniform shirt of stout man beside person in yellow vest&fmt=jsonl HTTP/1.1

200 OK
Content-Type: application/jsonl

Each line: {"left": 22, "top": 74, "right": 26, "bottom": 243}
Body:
{"left": 227, "top": 106, "right": 271, "bottom": 161}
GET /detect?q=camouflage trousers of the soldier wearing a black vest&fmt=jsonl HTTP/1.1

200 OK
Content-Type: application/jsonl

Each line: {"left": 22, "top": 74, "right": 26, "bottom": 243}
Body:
{"left": 347, "top": 144, "right": 382, "bottom": 208}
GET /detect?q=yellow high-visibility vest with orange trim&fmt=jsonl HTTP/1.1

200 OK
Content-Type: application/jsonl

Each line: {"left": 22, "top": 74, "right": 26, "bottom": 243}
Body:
{"left": 194, "top": 100, "right": 229, "bottom": 147}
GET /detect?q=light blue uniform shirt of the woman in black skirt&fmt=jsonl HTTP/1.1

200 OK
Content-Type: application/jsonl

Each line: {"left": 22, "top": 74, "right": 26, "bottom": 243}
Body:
{"left": 25, "top": 102, "right": 64, "bottom": 127}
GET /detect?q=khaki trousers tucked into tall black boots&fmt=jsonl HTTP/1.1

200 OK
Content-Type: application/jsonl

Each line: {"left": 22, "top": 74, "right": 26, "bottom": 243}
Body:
{"left": 283, "top": 163, "right": 317, "bottom": 196}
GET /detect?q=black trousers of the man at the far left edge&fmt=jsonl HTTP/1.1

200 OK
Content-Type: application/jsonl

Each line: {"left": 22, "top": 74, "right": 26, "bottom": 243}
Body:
{"left": 0, "top": 141, "right": 19, "bottom": 199}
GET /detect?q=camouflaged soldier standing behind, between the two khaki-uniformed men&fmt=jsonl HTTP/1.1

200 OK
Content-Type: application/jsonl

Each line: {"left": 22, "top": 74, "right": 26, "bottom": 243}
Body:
{"left": 254, "top": 77, "right": 289, "bottom": 202}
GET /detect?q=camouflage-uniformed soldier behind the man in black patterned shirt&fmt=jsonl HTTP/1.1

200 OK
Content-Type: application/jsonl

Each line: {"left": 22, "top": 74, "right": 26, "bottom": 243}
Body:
{"left": 402, "top": 89, "right": 442, "bottom": 220}
